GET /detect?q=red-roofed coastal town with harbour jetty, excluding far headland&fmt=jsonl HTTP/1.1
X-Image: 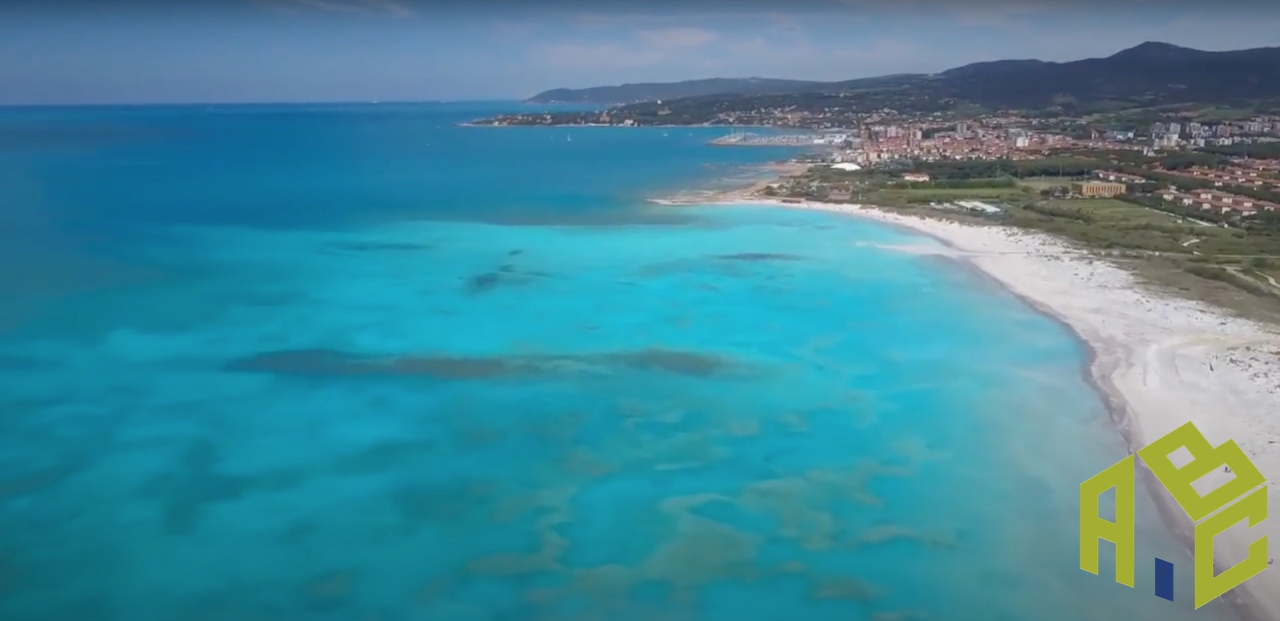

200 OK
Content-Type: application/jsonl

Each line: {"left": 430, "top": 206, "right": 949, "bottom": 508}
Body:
{"left": 713, "top": 117, "right": 1280, "bottom": 220}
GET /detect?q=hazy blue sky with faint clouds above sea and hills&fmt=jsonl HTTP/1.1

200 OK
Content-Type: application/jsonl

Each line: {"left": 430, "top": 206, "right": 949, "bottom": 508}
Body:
{"left": 0, "top": 0, "right": 1280, "bottom": 105}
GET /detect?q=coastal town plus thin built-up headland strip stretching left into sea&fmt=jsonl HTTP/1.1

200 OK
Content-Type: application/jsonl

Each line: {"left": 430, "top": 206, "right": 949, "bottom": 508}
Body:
{"left": 472, "top": 101, "right": 1280, "bottom": 223}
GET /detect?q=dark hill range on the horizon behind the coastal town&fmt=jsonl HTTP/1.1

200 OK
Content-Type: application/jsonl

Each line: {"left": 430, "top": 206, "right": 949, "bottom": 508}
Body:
{"left": 481, "top": 42, "right": 1280, "bottom": 127}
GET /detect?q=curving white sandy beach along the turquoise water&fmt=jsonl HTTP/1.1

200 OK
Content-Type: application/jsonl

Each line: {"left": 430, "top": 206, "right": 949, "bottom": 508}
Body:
{"left": 701, "top": 200, "right": 1280, "bottom": 618}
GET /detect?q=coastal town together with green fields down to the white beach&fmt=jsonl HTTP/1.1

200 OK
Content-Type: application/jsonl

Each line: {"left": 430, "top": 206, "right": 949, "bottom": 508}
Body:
{"left": 665, "top": 115, "right": 1280, "bottom": 330}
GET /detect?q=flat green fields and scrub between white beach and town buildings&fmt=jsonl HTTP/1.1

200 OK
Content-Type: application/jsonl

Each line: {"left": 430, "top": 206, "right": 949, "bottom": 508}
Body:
{"left": 778, "top": 161, "right": 1280, "bottom": 317}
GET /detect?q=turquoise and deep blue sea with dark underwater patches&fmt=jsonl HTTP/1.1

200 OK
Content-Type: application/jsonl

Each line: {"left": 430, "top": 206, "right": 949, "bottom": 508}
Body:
{"left": 0, "top": 104, "right": 1233, "bottom": 621}
